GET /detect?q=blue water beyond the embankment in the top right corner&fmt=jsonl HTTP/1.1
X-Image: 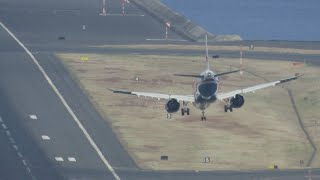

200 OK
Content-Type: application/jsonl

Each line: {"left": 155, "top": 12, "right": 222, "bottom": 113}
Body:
{"left": 161, "top": 0, "right": 320, "bottom": 41}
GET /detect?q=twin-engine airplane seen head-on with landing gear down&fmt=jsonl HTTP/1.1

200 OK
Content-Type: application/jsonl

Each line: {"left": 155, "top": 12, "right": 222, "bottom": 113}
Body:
{"left": 109, "top": 36, "right": 303, "bottom": 121}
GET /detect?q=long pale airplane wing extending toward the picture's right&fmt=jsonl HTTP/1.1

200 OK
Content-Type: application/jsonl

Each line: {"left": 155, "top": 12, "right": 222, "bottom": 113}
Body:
{"left": 216, "top": 75, "right": 302, "bottom": 100}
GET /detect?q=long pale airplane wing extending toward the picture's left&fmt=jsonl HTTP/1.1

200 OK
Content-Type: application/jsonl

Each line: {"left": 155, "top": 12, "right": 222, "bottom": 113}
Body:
{"left": 109, "top": 89, "right": 194, "bottom": 102}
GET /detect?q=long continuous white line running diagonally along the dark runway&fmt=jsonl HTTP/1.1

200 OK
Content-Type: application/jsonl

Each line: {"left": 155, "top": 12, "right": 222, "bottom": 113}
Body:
{"left": 0, "top": 22, "right": 120, "bottom": 180}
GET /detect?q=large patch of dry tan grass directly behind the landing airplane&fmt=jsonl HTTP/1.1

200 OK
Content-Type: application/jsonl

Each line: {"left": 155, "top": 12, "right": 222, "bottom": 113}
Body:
{"left": 59, "top": 54, "right": 320, "bottom": 170}
